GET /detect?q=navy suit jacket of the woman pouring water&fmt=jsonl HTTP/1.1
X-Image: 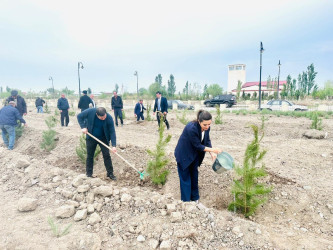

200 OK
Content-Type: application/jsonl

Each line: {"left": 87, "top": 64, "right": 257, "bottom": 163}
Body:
{"left": 175, "top": 122, "right": 212, "bottom": 169}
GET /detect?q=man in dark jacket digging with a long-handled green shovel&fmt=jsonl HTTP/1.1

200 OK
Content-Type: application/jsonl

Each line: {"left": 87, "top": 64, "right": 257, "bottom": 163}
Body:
{"left": 77, "top": 107, "right": 117, "bottom": 180}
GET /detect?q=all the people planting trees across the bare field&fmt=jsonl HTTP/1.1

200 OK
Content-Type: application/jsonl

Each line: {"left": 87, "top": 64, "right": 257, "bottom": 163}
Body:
{"left": 0, "top": 90, "right": 222, "bottom": 201}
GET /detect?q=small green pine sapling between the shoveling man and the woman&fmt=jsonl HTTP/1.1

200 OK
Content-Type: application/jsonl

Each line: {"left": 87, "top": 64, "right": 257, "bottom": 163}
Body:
{"left": 147, "top": 118, "right": 171, "bottom": 185}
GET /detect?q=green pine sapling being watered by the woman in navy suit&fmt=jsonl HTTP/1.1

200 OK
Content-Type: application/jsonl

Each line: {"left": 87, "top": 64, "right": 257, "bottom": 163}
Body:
{"left": 228, "top": 121, "right": 271, "bottom": 217}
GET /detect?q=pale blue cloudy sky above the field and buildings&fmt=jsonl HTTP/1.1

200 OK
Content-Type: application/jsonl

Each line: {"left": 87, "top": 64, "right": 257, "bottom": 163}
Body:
{"left": 0, "top": 0, "right": 333, "bottom": 93}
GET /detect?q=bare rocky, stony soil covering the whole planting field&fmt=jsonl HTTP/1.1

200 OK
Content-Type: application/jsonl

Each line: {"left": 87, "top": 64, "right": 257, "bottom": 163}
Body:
{"left": 0, "top": 102, "right": 333, "bottom": 249}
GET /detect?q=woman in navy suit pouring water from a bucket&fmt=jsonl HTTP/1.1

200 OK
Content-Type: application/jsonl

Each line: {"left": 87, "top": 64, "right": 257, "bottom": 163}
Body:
{"left": 175, "top": 110, "right": 222, "bottom": 202}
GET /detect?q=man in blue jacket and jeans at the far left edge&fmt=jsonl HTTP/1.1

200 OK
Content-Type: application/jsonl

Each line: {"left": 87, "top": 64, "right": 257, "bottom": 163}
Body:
{"left": 0, "top": 101, "right": 26, "bottom": 150}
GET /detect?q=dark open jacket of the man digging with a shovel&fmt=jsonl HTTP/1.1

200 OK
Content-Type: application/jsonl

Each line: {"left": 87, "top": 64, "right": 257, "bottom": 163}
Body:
{"left": 77, "top": 108, "right": 117, "bottom": 147}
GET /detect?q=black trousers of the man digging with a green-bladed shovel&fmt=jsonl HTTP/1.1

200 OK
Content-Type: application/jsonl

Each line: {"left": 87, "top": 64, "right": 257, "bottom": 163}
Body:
{"left": 86, "top": 137, "right": 113, "bottom": 176}
